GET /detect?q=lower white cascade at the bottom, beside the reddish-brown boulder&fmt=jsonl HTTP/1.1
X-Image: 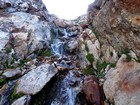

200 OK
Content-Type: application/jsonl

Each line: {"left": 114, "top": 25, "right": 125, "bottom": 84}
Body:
{"left": 51, "top": 70, "right": 82, "bottom": 105}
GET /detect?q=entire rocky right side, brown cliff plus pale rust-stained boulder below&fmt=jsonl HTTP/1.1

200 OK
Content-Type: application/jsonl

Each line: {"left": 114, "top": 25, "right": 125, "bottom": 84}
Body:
{"left": 87, "top": 0, "right": 140, "bottom": 105}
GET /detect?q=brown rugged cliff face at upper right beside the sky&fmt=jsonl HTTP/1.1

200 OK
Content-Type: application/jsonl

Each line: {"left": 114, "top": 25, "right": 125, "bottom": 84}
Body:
{"left": 88, "top": 0, "right": 140, "bottom": 56}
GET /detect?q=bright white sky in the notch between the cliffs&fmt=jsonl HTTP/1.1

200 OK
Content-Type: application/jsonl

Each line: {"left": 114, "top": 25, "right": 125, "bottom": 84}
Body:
{"left": 42, "top": 0, "right": 94, "bottom": 19}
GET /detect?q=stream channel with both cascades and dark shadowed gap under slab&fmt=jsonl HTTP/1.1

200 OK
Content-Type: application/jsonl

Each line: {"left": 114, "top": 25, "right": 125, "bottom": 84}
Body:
{"left": 31, "top": 29, "right": 83, "bottom": 105}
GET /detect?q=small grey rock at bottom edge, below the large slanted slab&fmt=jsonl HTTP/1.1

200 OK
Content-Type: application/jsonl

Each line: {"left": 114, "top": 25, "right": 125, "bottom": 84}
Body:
{"left": 12, "top": 95, "right": 31, "bottom": 105}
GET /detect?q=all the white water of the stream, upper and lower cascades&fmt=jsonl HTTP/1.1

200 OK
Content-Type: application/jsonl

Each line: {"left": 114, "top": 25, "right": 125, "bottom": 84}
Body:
{"left": 51, "top": 29, "right": 82, "bottom": 105}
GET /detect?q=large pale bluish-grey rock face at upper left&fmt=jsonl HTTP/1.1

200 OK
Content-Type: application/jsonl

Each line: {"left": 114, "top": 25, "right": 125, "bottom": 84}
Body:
{"left": 0, "top": 0, "right": 50, "bottom": 58}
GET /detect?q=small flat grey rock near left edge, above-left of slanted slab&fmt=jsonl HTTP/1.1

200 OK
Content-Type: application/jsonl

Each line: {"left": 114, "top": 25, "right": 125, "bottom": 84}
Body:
{"left": 2, "top": 69, "right": 21, "bottom": 78}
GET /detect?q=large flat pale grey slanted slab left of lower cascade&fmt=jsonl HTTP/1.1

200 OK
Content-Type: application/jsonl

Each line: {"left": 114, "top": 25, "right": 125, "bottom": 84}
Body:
{"left": 16, "top": 64, "right": 57, "bottom": 95}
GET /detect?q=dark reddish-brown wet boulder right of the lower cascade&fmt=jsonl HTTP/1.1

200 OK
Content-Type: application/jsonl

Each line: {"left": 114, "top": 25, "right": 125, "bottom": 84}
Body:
{"left": 83, "top": 76, "right": 102, "bottom": 105}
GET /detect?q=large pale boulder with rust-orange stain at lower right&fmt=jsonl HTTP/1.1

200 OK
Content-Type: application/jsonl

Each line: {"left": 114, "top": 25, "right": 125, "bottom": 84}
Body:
{"left": 104, "top": 55, "right": 140, "bottom": 105}
